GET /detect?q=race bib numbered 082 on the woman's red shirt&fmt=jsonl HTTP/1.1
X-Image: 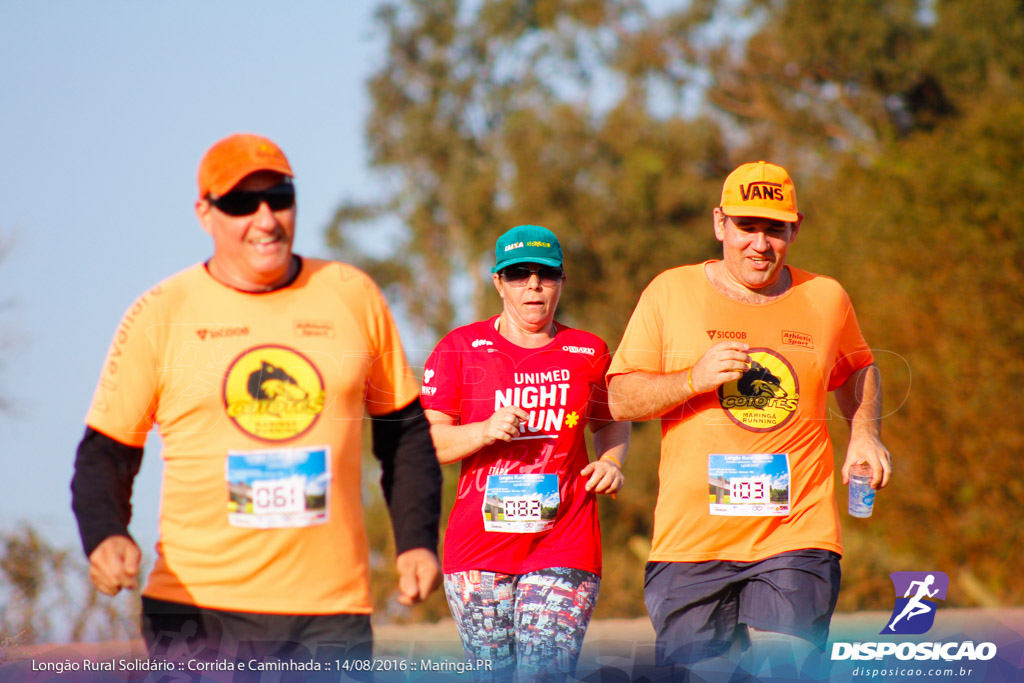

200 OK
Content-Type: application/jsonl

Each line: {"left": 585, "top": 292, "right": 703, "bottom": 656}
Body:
{"left": 482, "top": 474, "right": 561, "bottom": 533}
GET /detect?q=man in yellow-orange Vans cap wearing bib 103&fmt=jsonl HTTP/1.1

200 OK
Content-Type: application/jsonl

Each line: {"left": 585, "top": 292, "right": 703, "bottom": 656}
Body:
{"left": 608, "top": 161, "right": 892, "bottom": 677}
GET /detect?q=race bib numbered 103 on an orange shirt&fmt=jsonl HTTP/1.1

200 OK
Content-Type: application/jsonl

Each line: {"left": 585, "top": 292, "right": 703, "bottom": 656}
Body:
{"left": 708, "top": 453, "right": 790, "bottom": 517}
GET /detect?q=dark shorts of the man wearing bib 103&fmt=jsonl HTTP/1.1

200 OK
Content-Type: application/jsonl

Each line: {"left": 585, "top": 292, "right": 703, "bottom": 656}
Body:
{"left": 644, "top": 548, "right": 841, "bottom": 665}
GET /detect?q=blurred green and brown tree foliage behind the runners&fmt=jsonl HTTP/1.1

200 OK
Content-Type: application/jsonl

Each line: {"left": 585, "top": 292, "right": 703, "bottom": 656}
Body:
{"left": 330, "top": 0, "right": 1024, "bottom": 615}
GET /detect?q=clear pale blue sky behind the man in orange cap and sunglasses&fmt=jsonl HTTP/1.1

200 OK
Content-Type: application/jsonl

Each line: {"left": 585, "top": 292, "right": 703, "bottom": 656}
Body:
{"left": 0, "top": 0, "right": 393, "bottom": 561}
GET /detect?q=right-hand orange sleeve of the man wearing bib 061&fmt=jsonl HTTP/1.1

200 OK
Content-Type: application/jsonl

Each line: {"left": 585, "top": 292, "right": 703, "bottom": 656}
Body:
{"left": 366, "top": 278, "right": 420, "bottom": 416}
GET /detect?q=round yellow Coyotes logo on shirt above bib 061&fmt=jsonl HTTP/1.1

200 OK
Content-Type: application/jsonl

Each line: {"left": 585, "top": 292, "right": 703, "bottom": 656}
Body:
{"left": 224, "top": 346, "right": 324, "bottom": 441}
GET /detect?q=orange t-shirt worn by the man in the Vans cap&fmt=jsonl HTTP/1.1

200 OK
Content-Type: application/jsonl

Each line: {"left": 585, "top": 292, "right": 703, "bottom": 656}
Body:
{"left": 608, "top": 263, "right": 873, "bottom": 562}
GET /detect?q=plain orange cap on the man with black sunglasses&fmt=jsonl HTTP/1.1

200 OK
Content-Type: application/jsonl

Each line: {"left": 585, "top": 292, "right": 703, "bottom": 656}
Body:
{"left": 199, "top": 133, "right": 295, "bottom": 198}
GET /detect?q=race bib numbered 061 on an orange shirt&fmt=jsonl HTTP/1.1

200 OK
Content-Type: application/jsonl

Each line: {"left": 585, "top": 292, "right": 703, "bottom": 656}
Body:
{"left": 226, "top": 445, "right": 331, "bottom": 528}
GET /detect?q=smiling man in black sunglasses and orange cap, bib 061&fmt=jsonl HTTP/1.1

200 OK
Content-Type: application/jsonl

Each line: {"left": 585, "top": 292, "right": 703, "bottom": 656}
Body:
{"left": 72, "top": 134, "right": 440, "bottom": 661}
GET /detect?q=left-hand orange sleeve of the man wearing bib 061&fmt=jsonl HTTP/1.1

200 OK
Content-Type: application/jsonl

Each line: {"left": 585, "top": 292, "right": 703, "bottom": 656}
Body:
{"left": 85, "top": 289, "right": 160, "bottom": 447}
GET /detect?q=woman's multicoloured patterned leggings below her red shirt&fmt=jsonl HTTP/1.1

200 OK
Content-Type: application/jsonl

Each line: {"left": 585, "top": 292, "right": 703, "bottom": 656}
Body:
{"left": 444, "top": 567, "right": 601, "bottom": 681}
